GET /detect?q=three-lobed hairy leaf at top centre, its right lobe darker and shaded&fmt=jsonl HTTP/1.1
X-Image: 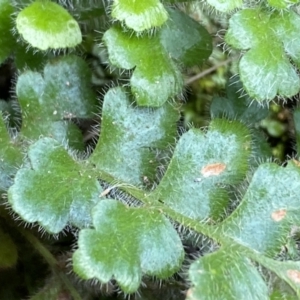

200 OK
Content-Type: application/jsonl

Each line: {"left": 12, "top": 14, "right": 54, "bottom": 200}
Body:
{"left": 103, "top": 10, "right": 212, "bottom": 106}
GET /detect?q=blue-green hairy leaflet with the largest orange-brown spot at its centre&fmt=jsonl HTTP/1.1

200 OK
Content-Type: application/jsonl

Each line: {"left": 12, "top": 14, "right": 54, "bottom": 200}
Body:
{"left": 153, "top": 119, "right": 251, "bottom": 220}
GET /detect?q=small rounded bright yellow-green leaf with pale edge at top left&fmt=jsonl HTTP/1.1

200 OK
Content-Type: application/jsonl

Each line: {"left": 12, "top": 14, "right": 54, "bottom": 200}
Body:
{"left": 16, "top": 0, "right": 82, "bottom": 50}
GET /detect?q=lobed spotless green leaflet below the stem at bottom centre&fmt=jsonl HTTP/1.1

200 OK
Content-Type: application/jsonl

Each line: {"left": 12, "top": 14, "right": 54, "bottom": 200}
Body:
{"left": 73, "top": 200, "right": 184, "bottom": 293}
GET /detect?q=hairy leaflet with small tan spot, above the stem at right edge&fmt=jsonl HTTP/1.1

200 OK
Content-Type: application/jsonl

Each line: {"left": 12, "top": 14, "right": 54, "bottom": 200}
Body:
{"left": 222, "top": 161, "right": 300, "bottom": 257}
